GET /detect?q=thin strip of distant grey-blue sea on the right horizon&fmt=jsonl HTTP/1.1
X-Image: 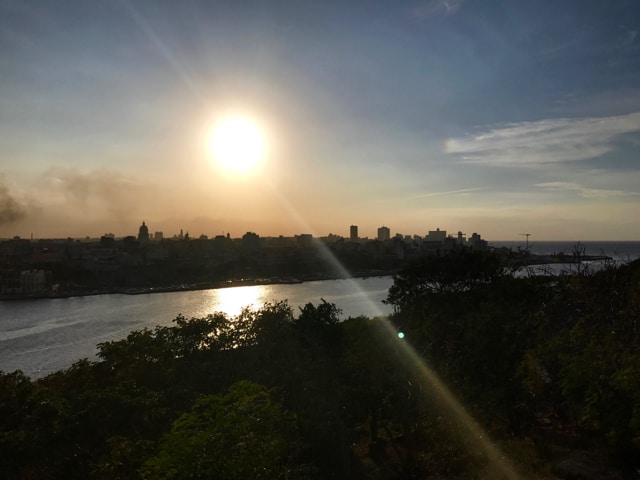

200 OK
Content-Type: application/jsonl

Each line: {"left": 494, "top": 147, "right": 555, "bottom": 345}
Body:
{"left": 489, "top": 240, "right": 640, "bottom": 262}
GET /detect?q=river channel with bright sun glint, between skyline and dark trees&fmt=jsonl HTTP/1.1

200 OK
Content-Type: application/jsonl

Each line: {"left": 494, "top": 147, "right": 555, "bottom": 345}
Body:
{"left": 0, "top": 277, "right": 393, "bottom": 378}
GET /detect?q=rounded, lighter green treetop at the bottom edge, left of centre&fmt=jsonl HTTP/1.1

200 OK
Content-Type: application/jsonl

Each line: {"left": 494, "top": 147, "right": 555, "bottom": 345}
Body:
{"left": 142, "top": 380, "right": 310, "bottom": 480}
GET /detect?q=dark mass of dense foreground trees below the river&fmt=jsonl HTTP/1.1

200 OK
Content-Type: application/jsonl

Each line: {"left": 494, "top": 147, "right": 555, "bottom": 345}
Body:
{"left": 0, "top": 249, "right": 640, "bottom": 479}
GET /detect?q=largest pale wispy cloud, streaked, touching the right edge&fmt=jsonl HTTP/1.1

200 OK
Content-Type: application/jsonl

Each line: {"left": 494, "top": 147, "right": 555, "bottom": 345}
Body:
{"left": 445, "top": 112, "right": 640, "bottom": 166}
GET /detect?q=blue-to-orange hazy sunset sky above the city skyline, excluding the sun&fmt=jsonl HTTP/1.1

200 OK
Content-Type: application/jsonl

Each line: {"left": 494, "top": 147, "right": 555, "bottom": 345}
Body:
{"left": 0, "top": 0, "right": 640, "bottom": 241}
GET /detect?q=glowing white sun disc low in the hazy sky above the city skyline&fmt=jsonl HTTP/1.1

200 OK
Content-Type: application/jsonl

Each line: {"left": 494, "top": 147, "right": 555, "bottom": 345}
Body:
{"left": 210, "top": 117, "right": 266, "bottom": 175}
